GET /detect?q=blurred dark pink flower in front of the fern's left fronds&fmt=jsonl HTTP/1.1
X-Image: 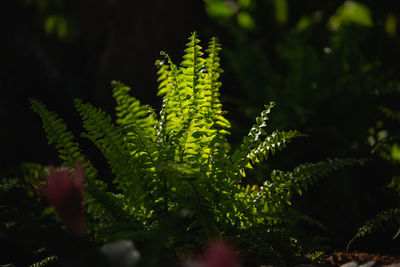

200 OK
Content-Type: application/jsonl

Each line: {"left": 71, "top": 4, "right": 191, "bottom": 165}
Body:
{"left": 39, "top": 162, "right": 85, "bottom": 236}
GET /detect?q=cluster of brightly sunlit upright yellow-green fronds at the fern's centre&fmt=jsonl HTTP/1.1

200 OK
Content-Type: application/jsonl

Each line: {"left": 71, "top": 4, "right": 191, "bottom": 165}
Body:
{"left": 157, "top": 33, "right": 230, "bottom": 169}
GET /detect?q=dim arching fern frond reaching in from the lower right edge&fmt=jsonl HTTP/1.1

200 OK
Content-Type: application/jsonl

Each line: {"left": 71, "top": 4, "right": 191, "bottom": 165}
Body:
{"left": 347, "top": 208, "right": 400, "bottom": 251}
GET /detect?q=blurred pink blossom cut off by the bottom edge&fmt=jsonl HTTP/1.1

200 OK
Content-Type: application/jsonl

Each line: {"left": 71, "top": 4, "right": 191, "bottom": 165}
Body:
{"left": 203, "top": 241, "right": 239, "bottom": 267}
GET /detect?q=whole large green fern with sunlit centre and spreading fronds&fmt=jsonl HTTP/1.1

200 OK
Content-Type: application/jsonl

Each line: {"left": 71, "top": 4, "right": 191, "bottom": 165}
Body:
{"left": 31, "top": 33, "right": 356, "bottom": 255}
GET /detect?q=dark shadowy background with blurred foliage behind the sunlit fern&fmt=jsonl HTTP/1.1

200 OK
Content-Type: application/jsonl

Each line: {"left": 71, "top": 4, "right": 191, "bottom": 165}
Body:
{"left": 0, "top": 0, "right": 400, "bottom": 253}
